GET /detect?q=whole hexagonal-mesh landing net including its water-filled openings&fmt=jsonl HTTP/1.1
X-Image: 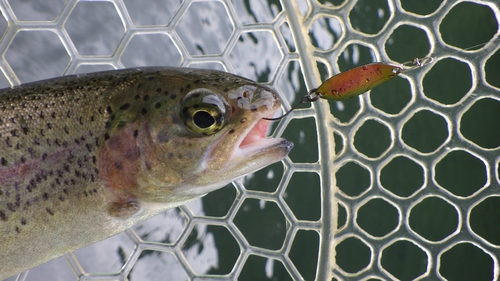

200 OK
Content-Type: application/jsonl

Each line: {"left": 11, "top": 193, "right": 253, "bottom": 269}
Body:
{"left": 0, "top": 0, "right": 500, "bottom": 280}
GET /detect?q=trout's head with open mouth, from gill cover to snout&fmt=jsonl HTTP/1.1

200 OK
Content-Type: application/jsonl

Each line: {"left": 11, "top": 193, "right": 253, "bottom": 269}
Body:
{"left": 120, "top": 69, "right": 293, "bottom": 202}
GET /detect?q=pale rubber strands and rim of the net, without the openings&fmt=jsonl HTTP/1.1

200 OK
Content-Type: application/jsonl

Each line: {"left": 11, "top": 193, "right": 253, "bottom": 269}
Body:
{"left": 0, "top": 0, "right": 500, "bottom": 280}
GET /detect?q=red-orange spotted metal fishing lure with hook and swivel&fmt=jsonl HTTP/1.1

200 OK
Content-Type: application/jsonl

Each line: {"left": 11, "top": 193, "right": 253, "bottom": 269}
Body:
{"left": 264, "top": 57, "right": 433, "bottom": 120}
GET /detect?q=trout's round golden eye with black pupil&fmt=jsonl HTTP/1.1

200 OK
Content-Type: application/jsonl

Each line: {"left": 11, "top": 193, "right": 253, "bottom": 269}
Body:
{"left": 181, "top": 89, "right": 230, "bottom": 136}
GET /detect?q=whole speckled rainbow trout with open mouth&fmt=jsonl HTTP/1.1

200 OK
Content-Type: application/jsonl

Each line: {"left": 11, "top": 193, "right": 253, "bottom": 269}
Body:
{"left": 0, "top": 67, "right": 293, "bottom": 279}
